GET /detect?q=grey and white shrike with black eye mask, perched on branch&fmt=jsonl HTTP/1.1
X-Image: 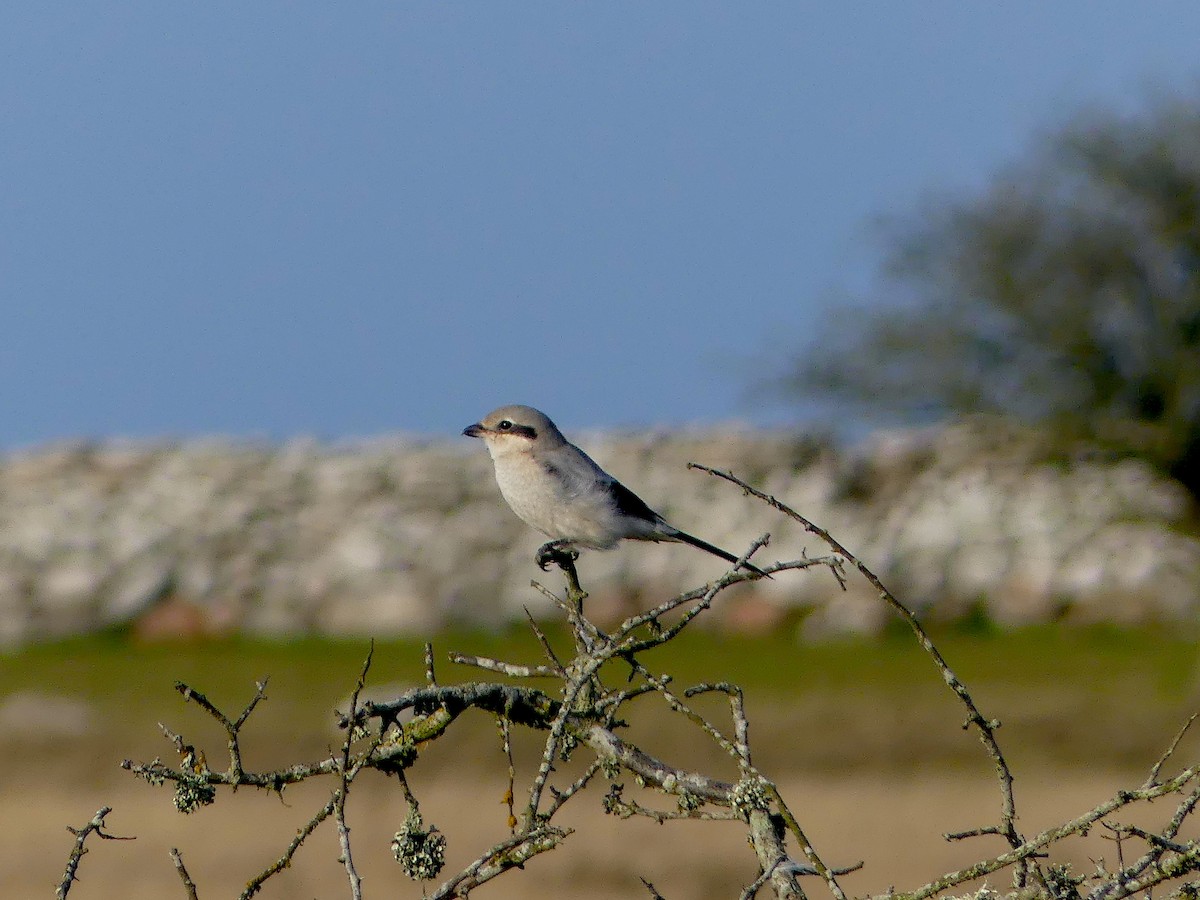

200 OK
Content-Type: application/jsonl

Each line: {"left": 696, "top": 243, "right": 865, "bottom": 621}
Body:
{"left": 462, "top": 406, "right": 769, "bottom": 577}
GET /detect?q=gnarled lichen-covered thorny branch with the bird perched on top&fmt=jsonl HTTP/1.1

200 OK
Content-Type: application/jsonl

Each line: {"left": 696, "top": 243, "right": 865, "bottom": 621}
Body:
{"left": 112, "top": 501, "right": 845, "bottom": 900}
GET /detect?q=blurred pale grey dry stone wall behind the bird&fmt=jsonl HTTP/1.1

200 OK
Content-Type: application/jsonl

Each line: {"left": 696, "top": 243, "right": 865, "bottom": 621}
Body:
{"left": 0, "top": 424, "right": 1200, "bottom": 644}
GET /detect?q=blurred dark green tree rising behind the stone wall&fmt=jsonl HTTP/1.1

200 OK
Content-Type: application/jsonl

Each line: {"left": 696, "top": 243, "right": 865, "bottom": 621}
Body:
{"left": 787, "top": 101, "right": 1200, "bottom": 497}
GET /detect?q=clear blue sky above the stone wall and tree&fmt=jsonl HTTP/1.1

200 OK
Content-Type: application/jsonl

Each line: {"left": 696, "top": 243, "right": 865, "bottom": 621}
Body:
{"left": 0, "top": 0, "right": 1200, "bottom": 448}
